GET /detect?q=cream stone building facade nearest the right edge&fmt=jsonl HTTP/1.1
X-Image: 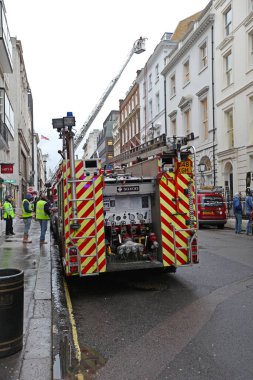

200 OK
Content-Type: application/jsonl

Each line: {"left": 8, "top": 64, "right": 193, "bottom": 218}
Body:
{"left": 214, "top": 0, "right": 253, "bottom": 196}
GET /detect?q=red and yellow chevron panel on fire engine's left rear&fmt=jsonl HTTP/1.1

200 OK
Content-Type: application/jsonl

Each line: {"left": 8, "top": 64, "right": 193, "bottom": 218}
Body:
{"left": 64, "top": 160, "right": 106, "bottom": 275}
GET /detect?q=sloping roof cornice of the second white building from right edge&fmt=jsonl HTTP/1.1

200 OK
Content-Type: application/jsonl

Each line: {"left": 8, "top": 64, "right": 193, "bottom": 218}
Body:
{"left": 161, "top": 14, "right": 215, "bottom": 75}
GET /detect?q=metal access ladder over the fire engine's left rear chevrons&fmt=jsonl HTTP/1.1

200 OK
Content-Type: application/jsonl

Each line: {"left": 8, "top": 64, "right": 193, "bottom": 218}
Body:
{"left": 66, "top": 178, "right": 99, "bottom": 276}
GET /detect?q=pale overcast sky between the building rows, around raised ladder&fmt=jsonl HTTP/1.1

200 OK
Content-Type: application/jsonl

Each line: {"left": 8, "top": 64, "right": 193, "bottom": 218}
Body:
{"left": 4, "top": 0, "right": 209, "bottom": 169}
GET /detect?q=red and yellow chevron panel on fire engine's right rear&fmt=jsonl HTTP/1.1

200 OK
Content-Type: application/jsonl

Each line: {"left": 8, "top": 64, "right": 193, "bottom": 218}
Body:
{"left": 159, "top": 173, "right": 195, "bottom": 266}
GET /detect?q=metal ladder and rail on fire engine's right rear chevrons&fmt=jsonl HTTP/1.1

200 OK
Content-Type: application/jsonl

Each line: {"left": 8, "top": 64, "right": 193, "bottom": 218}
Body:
{"left": 172, "top": 177, "right": 197, "bottom": 266}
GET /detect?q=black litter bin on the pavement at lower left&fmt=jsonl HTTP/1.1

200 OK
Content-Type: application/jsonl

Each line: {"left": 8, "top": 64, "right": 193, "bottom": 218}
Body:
{"left": 0, "top": 269, "right": 24, "bottom": 358}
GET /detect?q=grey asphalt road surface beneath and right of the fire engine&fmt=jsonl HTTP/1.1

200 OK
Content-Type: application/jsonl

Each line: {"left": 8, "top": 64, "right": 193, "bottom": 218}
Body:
{"left": 69, "top": 228, "right": 253, "bottom": 380}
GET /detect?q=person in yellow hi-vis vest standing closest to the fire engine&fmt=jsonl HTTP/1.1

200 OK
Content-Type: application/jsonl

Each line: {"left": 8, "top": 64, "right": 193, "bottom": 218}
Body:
{"left": 35, "top": 194, "right": 51, "bottom": 245}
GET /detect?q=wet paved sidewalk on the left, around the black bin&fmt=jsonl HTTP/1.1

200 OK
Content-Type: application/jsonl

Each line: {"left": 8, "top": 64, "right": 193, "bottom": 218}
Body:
{"left": 0, "top": 219, "right": 53, "bottom": 380}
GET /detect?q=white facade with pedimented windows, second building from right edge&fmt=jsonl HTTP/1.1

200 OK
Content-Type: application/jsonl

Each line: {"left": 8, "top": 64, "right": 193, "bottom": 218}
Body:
{"left": 162, "top": 4, "right": 217, "bottom": 190}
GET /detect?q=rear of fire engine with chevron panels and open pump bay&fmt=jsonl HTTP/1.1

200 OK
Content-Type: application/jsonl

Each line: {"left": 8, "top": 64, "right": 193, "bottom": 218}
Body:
{"left": 50, "top": 121, "right": 198, "bottom": 276}
